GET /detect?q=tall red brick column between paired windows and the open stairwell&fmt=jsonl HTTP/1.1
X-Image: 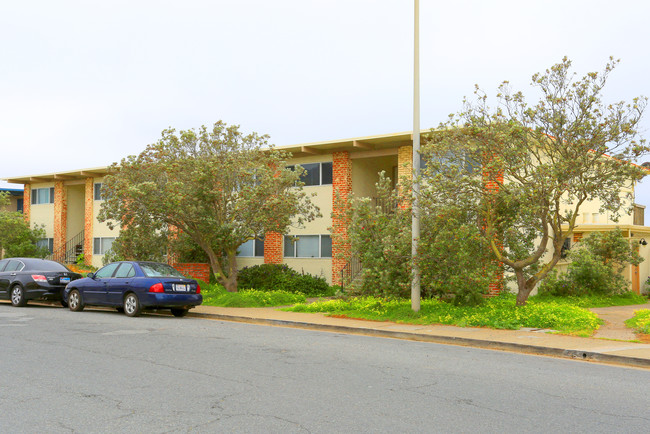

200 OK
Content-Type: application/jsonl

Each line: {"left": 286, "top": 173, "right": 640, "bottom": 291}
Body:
{"left": 332, "top": 151, "right": 352, "bottom": 285}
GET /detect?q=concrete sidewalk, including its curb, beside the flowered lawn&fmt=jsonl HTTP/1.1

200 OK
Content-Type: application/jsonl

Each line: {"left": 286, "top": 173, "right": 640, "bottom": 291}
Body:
{"left": 190, "top": 303, "right": 650, "bottom": 369}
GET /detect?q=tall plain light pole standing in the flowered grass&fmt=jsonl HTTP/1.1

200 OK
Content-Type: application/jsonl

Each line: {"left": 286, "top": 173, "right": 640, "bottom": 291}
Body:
{"left": 411, "top": 0, "right": 420, "bottom": 312}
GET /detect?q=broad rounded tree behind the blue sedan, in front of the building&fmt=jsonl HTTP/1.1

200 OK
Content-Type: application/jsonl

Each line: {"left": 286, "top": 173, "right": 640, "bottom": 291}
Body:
{"left": 99, "top": 121, "right": 319, "bottom": 291}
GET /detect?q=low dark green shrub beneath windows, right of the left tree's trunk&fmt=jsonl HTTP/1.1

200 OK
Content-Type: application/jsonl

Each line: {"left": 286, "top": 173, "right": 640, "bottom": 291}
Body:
{"left": 237, "top": 264, "right": 334, "bottom": 297}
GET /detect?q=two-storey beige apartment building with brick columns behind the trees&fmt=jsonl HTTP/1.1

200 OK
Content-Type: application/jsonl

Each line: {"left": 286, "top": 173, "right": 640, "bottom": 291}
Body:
{"left": 6, "top": 131, "right": 650, "bottom": 292}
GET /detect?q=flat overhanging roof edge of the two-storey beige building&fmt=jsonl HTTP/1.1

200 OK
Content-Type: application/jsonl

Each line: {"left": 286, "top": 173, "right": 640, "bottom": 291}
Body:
{"left": 3, "top": 130, "right": 431, "bottom": 184}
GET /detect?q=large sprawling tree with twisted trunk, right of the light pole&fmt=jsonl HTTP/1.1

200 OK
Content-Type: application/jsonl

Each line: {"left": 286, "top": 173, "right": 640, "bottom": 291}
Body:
{"left": 423, "top": 58, "right": 649, "bottom": 305}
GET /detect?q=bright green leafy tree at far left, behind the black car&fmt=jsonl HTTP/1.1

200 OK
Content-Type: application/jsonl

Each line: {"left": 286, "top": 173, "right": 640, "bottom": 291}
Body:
{"left": 0, "top": 192, "right": 48, "bottom": 259}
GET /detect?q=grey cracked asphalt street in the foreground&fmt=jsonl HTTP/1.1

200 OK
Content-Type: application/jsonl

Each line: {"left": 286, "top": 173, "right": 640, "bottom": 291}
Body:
{"left": 0, "top": 304, "right": 650, "bottom": 433}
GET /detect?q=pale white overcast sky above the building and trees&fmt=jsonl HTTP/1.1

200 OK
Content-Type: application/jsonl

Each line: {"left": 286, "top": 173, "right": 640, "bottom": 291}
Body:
{"left": 0, "top": 0, "right": 650, "bottom": 205}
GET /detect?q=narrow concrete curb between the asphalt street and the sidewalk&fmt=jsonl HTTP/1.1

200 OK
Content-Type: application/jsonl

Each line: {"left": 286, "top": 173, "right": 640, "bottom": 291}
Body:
{"left": 188, "top": 312, "right": 650, "bottom": 369}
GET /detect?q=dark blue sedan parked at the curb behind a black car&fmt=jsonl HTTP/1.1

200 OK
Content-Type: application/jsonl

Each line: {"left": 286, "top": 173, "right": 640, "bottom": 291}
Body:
{"left": 63, "top": 261, "right": 203, "bottom": 316}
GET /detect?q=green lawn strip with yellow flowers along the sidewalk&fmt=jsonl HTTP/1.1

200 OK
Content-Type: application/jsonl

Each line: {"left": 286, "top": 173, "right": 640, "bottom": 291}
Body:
{"left": 200, "top": 282, "right": 650, "bottom": 336}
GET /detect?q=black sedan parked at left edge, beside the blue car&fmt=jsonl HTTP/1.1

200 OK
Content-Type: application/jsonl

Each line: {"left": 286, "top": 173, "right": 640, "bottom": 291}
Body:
{"left": 0, "top": 258, "right": 81, "bottom": 306}
